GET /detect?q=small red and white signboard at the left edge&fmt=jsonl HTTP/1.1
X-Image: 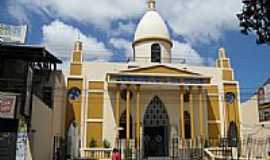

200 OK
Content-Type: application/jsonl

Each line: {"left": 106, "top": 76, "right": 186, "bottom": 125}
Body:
{"left": 0, "top": 94, "right": 16, "bottom": 119}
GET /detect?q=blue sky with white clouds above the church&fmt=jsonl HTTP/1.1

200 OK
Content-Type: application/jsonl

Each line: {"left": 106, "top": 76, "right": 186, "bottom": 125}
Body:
{"left": 0, "top": 0, "right": 270, "bottom": 99}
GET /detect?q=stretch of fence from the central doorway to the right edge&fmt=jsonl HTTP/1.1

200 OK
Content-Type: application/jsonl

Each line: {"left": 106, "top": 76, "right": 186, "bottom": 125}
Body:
{"left": 127, "top": 137, "right": 270, "bottom": 160}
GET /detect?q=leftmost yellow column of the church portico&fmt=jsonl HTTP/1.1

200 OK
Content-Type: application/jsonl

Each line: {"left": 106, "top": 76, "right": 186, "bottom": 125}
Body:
{"left": 115, "top": 84, "right": 120, "bottom": 147}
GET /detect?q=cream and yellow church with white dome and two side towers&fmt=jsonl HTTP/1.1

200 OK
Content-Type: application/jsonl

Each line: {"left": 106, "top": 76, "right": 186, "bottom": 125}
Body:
{"left": 66, "top": 0, "right": 241, "bottom": 157}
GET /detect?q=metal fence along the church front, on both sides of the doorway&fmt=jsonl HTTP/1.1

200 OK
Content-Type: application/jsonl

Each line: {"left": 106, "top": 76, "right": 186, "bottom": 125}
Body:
{"left": 76, "top": 137, "right": 270, "bottom": 160}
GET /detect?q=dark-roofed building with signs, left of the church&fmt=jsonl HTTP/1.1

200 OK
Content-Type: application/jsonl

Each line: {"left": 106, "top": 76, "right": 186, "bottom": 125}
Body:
{"left": 0, "top": 43, "right": 66, "bottom": 160}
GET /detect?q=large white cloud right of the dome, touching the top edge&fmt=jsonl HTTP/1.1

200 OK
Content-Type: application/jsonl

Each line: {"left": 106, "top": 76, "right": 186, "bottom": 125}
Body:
{"left": 159, "top": 0, "right": 241, "bottom": 43}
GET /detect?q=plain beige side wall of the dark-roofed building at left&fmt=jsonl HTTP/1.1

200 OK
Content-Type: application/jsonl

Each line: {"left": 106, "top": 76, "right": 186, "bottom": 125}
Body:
{"left": 31, "top": 71, "right": 66, "bottom": 160}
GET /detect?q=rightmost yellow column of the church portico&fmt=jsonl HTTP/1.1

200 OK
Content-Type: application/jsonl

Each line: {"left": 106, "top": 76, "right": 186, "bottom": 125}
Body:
{"left": 198, "top": 86, "right": 204, "bottom": 138}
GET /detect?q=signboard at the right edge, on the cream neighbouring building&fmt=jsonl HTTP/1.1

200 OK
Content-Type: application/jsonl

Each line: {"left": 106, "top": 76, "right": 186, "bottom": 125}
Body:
{"left": 257, "top": 80, "right": 270, "bottom": 122}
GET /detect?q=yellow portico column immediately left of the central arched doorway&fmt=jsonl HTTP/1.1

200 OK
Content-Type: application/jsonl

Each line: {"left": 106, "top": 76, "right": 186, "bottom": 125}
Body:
{"left": 136, "top": 85, "right": 141, "bottom": 149}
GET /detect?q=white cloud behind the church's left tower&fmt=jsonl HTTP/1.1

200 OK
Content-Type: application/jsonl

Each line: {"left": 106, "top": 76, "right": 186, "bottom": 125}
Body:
{"left": 42, "top": 20, "right": 112, "bottom": 60}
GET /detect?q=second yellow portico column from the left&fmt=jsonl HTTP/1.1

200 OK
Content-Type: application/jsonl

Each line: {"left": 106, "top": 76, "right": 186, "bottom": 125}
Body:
{"left": 126, "top": 85, "right": 130, "bottom": 149}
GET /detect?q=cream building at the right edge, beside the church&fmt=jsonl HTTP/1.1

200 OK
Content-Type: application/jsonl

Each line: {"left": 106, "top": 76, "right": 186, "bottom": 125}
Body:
{"left": 241, "top": 79, "right": 270, "bottom": 157}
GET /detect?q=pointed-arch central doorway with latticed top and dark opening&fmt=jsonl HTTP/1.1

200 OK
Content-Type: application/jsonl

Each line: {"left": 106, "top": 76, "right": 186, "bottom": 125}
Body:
{"left": 143, "top": 96, "right": 170, "bottom": 157}
